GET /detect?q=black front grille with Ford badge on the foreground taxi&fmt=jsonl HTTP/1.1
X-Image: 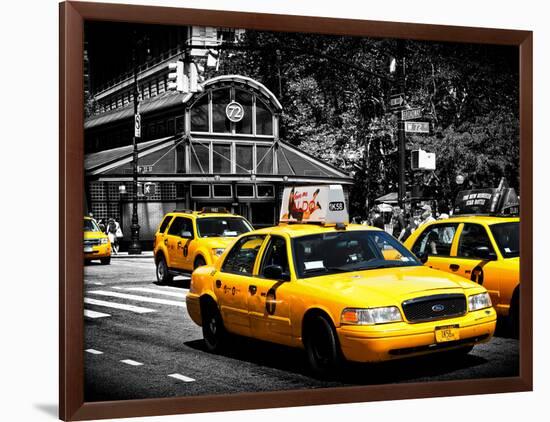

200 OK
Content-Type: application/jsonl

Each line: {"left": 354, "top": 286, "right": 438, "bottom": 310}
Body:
{"left": 401, "top": 294, "right": 466, "bottom": 322}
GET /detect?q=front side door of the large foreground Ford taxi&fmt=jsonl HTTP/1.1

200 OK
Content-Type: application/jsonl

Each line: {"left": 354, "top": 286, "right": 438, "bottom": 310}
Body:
{"left": 248, "top": 236, "right": 293, "bottom": 343}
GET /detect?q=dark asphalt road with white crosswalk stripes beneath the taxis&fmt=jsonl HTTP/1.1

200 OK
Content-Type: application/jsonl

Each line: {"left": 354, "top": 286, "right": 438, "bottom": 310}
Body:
{"left": 84, "top": 258, "right": 519, "bottom": 401}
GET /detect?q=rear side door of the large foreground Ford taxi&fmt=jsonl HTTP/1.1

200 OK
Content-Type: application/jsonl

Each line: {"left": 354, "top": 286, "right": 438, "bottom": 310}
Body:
{"left": 214, "top": 235, "right": 265, "bottom": 336}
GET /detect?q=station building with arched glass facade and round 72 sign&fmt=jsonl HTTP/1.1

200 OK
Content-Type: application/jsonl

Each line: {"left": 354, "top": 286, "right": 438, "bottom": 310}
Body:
{"left": 85, "top": 26, "right": 353, "bottom": 248}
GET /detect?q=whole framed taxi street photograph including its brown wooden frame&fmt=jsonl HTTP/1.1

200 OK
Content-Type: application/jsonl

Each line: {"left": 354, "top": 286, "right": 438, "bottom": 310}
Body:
{"left": 59, "top": 2, "right": 533, "bottom": 420}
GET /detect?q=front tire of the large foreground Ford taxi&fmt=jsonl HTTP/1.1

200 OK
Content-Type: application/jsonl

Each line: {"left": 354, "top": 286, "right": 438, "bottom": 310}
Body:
{"left": 304, "top": 315, "right": 343, "bottom": 379}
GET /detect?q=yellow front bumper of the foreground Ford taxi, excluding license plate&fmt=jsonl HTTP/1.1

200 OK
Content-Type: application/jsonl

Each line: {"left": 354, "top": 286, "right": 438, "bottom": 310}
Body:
{"left": 337, "top": 308, "right": 496, "bottom": 362}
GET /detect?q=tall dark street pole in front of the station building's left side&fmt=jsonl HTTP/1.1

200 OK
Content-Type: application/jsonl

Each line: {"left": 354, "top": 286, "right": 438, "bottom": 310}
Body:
{"left": 128, "top": 42, "right": 141, "bottom": 255}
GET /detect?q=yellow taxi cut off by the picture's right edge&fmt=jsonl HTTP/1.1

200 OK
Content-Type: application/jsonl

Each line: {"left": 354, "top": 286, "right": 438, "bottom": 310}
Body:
{"left": 405, "top": 189, "right": 520, "bottom": 334}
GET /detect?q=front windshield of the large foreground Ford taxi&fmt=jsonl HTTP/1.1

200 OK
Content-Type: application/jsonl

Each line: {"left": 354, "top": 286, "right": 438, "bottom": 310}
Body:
{"left": 293, "top": 230, "right": 421, "bottom": 278}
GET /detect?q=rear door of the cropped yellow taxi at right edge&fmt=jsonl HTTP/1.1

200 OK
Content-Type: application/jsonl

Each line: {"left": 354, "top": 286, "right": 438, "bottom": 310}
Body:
{"left": 411, "top": 223, "right": 460, "bottom": 272}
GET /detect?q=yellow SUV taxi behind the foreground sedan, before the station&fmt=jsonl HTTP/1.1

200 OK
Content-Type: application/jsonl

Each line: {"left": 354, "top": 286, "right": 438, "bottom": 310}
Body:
{"left": 153, "top": 207, "right": 253, "bottom": 283}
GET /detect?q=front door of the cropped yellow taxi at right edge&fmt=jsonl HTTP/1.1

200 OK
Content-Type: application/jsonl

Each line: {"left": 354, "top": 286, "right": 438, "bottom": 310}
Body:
{"left": 451, "top": 223, "right": 500, "bottom": 306}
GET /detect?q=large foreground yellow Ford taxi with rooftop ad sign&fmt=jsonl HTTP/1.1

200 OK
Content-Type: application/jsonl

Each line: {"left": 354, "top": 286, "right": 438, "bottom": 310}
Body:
{"left": 186, "top": 185, "right": 496, "bottom": 375}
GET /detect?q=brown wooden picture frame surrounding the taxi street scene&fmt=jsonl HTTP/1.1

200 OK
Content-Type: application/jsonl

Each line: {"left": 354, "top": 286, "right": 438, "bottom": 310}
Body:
{"left": 59, "top": 2, "right": 533, "bottom": 420}
